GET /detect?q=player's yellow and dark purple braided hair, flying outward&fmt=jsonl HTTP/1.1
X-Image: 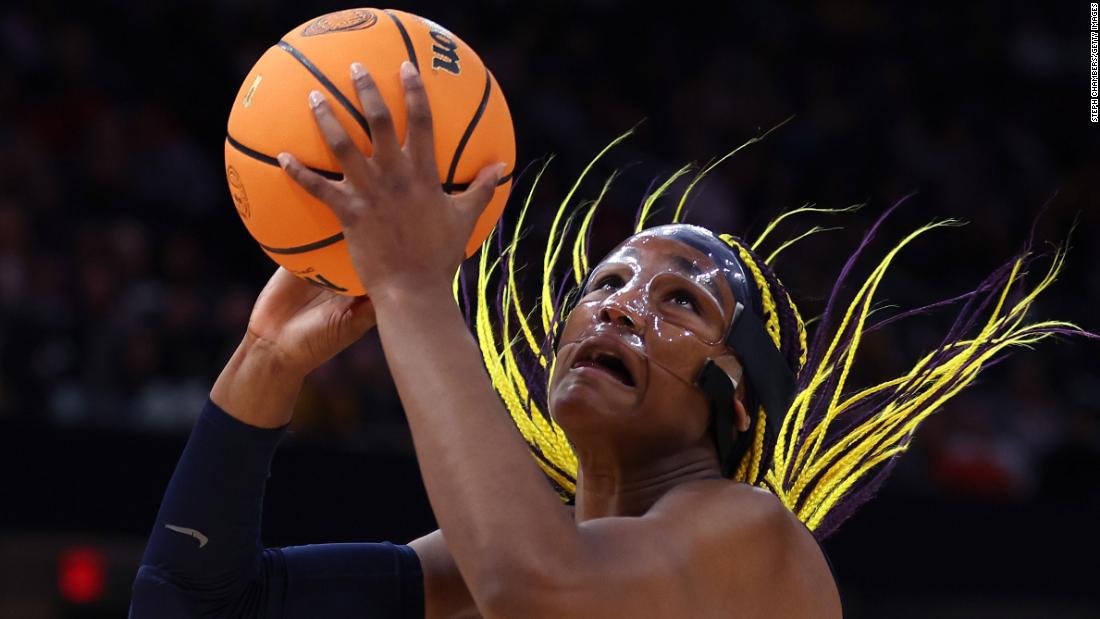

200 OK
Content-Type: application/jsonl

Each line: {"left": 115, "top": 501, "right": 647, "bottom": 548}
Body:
{"left": 453, "top": 132, "right": 1098, "bottom": 540}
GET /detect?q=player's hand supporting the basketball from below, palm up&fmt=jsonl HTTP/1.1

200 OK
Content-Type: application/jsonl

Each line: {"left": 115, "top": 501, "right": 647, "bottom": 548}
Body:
{"left": 248, "top": 267, "right": 375, "bottom": 377}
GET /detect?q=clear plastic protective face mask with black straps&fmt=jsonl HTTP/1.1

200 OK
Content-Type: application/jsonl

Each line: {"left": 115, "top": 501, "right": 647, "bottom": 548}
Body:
{"left": 557, "top": 223, "right": 798, "bottom": 477}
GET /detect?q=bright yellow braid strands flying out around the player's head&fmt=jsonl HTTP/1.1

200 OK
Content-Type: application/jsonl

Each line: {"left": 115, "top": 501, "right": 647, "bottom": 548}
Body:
{"left": 454, "top": 132, "right": 1086, "bottom": 538}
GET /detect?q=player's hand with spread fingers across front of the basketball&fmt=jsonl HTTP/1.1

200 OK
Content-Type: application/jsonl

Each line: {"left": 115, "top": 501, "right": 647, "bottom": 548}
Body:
{"left": 278, "top": 62, "right": 505, "bottom": 296}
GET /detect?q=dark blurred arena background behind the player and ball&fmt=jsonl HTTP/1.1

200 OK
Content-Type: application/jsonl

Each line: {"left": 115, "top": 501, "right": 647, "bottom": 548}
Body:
{"left": 0, "top": 0, "right": 1100, "bottom": 619}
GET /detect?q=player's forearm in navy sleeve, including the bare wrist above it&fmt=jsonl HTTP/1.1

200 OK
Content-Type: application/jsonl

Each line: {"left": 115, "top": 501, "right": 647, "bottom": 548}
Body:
{"left": 133, "top": 338, "right": 300, "bottom": 617}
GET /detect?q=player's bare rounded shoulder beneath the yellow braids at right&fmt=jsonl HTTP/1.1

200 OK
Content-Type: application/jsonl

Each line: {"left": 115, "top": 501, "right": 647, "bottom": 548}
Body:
{"left": 655, "top": 479, "right": 842, "bottom": 618}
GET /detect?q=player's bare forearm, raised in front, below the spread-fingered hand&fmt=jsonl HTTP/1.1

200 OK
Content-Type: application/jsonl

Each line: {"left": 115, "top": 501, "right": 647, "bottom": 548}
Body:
{"left": 373, "top": 286, "right": 576, "bottom": 598}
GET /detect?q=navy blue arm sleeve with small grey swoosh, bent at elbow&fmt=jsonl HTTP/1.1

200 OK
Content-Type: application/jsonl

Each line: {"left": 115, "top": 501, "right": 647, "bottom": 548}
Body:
{"left": 130, "top": 402, "right": 424, "bottom": 619}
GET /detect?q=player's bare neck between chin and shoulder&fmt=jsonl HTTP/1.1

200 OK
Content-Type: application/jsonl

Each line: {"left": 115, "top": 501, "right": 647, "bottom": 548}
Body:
{"left": 574, "top": 447, "right": 721, "bottom": 522}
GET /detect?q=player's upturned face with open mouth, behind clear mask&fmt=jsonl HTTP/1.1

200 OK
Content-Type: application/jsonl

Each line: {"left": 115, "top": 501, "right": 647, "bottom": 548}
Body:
{"left": 550, "top": 228, "right": 735, "bottom": 454}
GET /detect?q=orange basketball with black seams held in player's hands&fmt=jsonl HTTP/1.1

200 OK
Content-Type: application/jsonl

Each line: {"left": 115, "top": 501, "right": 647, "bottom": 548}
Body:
{"left": 226, "top": 9, "right": 516, "bottom": 295}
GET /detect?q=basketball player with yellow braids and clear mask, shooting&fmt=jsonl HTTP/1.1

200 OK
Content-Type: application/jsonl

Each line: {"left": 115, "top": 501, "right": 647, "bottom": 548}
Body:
{"left": 131, "top": 63, "right": 1076, "bottom": 618}
